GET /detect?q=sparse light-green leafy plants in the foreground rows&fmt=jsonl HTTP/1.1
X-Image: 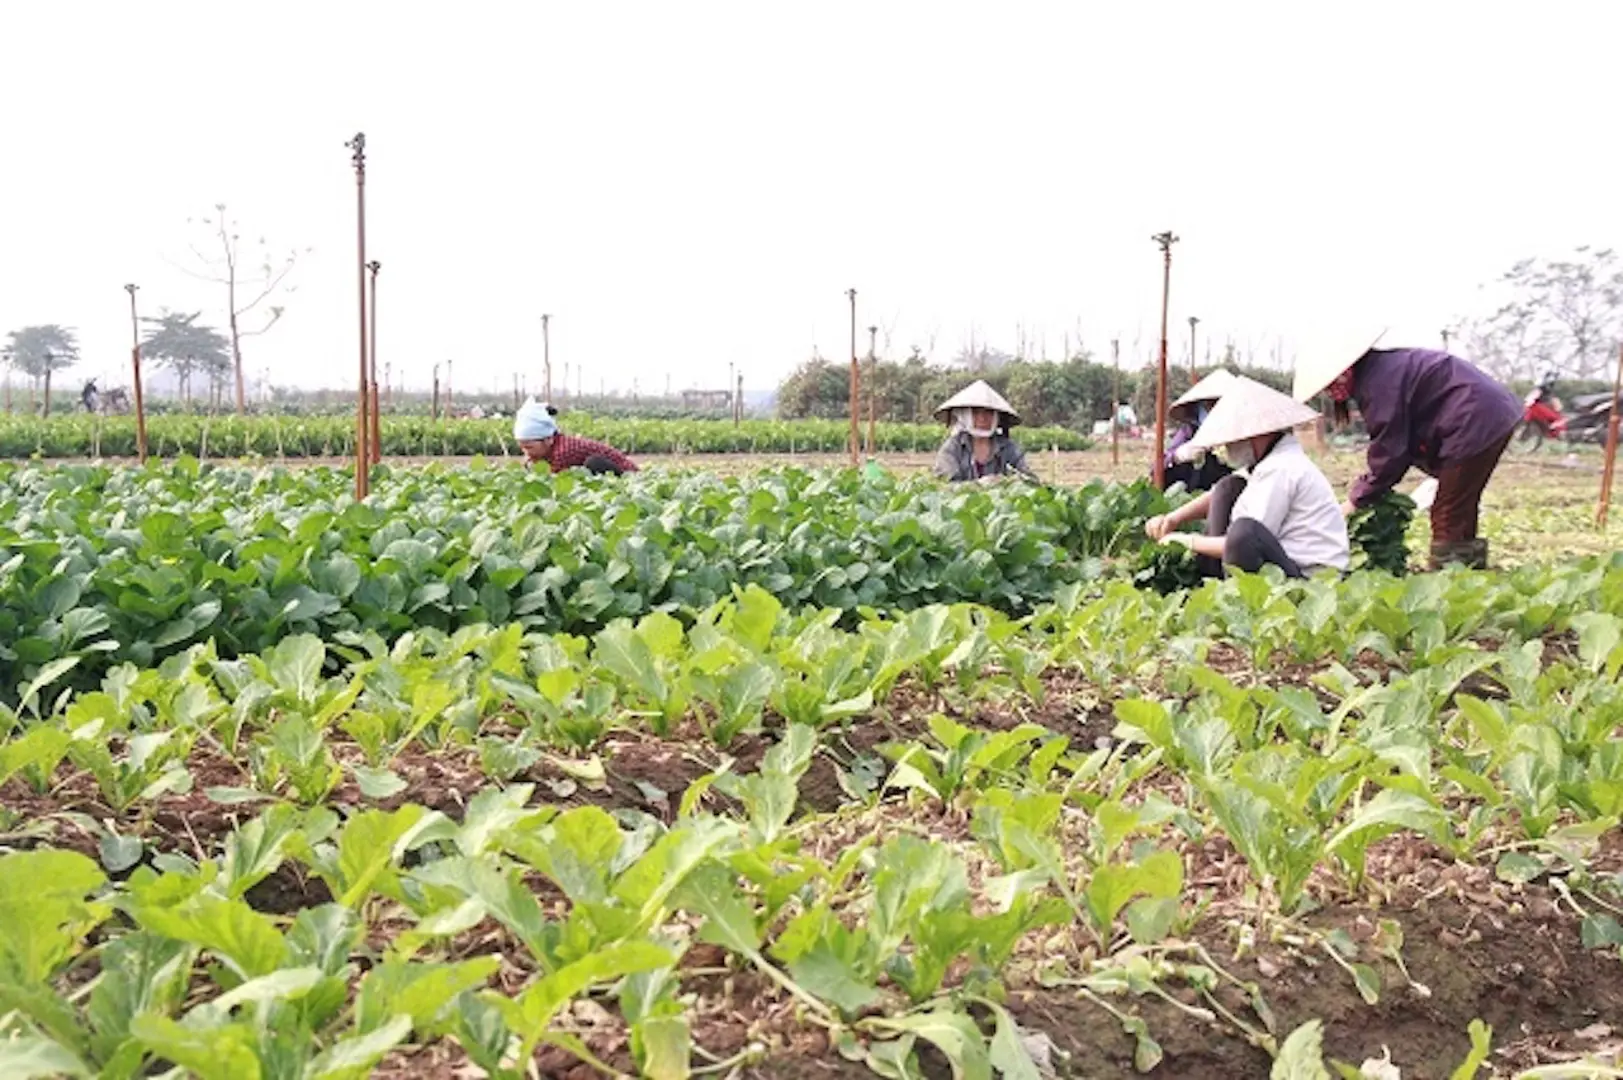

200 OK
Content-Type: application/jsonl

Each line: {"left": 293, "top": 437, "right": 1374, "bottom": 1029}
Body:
{"left": 0, "top": 557, "right": 1623, "bottom": 1078}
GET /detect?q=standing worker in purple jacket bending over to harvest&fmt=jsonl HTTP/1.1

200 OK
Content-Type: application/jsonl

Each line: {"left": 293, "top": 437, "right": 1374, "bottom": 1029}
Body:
{"left": 1295, "top": 331, "right": 1522, "bottom": 568}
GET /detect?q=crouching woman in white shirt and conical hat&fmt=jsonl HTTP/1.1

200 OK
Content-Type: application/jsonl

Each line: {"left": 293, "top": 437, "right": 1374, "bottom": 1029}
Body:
{"left": 1144, "top": 377, "right": 1350, "bottom": 578}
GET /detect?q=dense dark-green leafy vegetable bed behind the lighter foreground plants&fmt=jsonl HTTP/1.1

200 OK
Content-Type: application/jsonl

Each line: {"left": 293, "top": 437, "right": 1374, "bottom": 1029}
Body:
{"left": 0, "top": 461, "right": 1162, "bottom": 690}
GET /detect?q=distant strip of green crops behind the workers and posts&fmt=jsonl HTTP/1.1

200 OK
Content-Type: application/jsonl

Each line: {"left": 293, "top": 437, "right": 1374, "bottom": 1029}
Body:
{"left": 0, "top": 413, "right": 1089, "bottom": 460}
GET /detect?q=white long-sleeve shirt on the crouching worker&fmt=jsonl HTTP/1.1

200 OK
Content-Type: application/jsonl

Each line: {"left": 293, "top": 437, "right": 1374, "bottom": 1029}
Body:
{"left": 1233, "top": 434, "right": 1350, "bottom": 573}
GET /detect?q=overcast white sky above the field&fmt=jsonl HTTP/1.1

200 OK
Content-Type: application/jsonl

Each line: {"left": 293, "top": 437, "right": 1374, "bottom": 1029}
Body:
{"left": 0, "top": 0, "right": 1623, "bottom": 390}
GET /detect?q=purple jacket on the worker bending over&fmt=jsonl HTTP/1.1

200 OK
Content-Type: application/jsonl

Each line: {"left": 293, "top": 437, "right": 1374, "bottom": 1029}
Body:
{"left": 1350, "top": 349, "right": 1522, "bottom": 507}
